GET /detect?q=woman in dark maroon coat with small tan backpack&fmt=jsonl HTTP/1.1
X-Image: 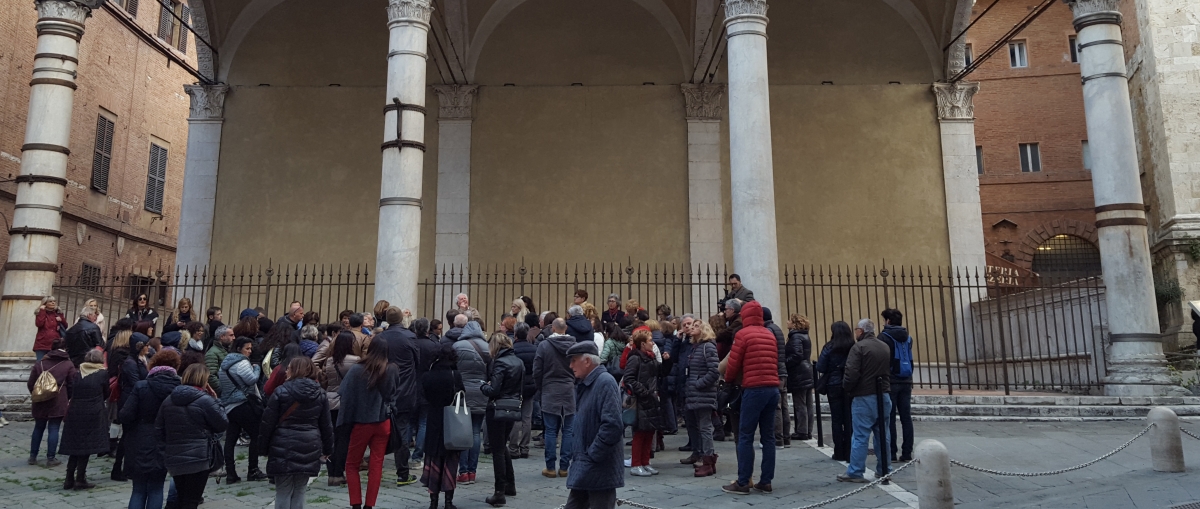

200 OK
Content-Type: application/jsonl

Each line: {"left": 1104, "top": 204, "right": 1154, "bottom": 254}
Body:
{"left": 29, "top": 337, "right": 79, "bottom": 467}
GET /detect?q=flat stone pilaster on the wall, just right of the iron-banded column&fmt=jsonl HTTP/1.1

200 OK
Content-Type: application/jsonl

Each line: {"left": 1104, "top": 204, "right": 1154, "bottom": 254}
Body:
{"left": 433, "top": 85, "right": 479, "bottom": 272}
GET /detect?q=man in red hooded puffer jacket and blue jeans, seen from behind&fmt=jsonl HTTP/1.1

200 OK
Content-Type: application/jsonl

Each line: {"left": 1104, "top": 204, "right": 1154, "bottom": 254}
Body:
{"left": 721, "top": 300, "right": 779, "bottom": 495}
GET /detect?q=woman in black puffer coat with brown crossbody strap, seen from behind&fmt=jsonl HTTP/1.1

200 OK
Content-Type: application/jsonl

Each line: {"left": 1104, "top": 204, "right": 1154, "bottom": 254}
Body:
{"left": 258, "top": 355, "right": 334, "bottom": 509}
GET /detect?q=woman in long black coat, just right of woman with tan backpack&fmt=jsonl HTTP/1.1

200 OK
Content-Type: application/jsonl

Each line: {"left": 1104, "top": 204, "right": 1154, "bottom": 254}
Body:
{"left": 59, "top": 349, "right": 108, "bottom": 490}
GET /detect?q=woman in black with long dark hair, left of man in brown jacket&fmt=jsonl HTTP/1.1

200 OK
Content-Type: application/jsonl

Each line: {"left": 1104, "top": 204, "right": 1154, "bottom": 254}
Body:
{"left": 816, "top": 322, "right": 854, "bottom": 461}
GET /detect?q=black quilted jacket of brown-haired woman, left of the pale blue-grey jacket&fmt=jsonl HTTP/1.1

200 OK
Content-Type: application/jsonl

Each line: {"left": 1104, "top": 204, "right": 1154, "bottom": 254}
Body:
{"left": 154, "top": 385, "right": 229, "bottom": 477}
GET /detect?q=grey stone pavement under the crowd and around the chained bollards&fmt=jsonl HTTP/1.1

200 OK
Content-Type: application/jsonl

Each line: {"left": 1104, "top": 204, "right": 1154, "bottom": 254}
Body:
{"left": 0, "top": 421, "right": 1200, "bottom": 509}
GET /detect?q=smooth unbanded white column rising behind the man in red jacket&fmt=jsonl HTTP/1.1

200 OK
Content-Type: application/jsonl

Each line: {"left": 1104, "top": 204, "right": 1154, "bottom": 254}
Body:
{"left": 725, "top": 0, "right": 782, "bottom": 312}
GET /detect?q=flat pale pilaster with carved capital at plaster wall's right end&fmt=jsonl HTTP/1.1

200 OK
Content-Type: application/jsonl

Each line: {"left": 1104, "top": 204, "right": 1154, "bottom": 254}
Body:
{"left": 934, "top": 82, "right": 988, "bottom": 274}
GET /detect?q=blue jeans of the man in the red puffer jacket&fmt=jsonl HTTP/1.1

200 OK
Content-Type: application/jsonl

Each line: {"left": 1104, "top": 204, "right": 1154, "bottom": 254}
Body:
{"left": 729, "top": 387, "right": 779, "bottom": 486}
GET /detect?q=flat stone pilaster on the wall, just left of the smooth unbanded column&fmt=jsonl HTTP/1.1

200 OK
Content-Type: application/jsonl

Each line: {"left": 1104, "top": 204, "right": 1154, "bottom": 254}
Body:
{"left": 679, "top": 83, "right": 725, "bottom": 316}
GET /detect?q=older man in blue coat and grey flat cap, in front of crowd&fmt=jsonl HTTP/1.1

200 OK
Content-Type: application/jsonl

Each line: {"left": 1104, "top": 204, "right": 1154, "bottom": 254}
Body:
{"left": 565, "top": 341, "right": 625, "bottom": 509}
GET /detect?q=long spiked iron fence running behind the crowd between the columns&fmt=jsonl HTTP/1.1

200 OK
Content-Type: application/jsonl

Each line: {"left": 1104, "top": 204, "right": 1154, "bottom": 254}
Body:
{"left": 55, "top": 263, "right": 1106, "bottom": 394}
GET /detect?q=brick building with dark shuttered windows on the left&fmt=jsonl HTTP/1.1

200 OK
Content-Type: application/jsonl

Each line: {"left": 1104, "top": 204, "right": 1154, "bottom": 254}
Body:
{"left": 0, "top": 0, "right": 199, "bottom": 306}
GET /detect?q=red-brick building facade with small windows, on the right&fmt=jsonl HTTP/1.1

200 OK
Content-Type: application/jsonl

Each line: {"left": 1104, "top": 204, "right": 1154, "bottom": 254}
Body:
{"left": 966, "top": 0, "right": 1096, "bottom": 268}
